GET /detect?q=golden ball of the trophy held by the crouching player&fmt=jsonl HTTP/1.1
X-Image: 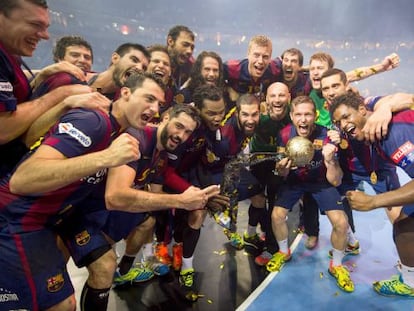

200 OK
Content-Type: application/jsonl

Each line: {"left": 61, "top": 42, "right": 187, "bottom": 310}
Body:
{"left": 286, "top": 136, "right": 315, "bottom": 167}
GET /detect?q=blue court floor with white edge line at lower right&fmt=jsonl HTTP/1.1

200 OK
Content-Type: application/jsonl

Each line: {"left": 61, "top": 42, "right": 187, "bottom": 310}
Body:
{"left": 237, "top": 171, "right": 414, "bottom": 311}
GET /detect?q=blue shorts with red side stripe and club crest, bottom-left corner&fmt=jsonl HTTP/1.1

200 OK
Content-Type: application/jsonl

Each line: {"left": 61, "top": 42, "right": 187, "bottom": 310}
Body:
{"left": 0, "top": 227, "right": 74, "bottom": 310}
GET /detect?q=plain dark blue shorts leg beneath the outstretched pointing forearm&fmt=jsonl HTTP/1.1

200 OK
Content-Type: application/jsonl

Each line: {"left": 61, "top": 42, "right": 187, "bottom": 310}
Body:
{"left": 102, "top": 211, "right": 149, "bottom": 242}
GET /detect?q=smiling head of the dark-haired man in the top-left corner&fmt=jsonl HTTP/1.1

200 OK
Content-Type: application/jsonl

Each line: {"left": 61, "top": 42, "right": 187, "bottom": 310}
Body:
{"left": 0, "top": 1, "right": 50, "bottom": 56}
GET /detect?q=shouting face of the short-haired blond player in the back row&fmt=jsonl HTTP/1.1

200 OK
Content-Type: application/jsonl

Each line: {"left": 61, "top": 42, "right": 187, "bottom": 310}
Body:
{"left": 247, "top": 43, "right": 272, "bottom": 81}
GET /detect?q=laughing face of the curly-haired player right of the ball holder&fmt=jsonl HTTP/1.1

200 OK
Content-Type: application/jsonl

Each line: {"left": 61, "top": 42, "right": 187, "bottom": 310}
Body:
{"left": 332, "top": 104, "right": 367, "bottom": 141}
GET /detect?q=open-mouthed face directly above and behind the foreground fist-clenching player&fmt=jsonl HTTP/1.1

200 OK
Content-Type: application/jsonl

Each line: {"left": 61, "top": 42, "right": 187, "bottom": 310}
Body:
{"left": 112, "top": 49, "right": 149, "bottom": 86}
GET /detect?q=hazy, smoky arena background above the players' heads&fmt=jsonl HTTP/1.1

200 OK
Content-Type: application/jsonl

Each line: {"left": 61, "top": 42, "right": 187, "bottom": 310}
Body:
{"left": 27, "top": 0, "right": 414, "bottom": 95}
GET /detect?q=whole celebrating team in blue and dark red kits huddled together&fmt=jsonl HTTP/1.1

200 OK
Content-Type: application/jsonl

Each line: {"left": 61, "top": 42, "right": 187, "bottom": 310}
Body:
{"left": 0, "top": 0, "right": 414, "bottom": 310}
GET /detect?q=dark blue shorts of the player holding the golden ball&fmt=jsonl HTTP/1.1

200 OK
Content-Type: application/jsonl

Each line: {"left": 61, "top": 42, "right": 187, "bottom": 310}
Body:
{"left": 275, "top": 182, "right": 344, "bottom": 212}
